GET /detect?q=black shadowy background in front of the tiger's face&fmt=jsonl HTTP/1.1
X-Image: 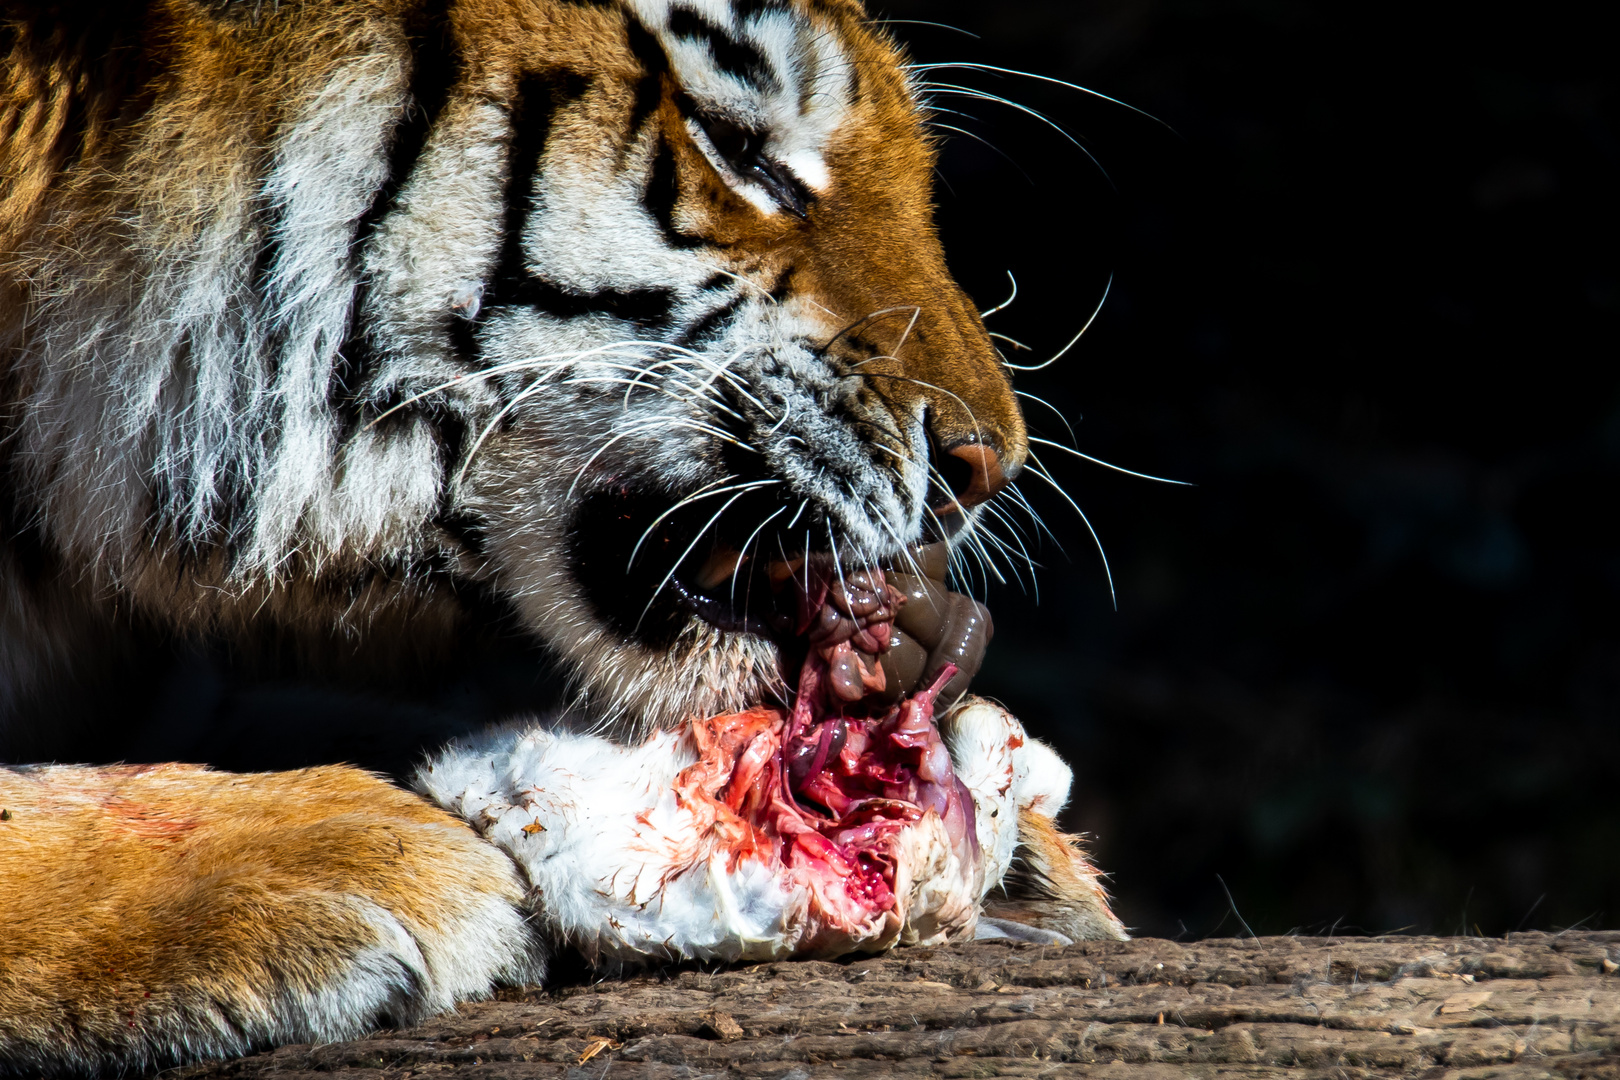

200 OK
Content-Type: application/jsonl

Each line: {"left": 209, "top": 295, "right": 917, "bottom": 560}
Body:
{"left": 883, "top": 0, "right": 1620, "bottom": 938}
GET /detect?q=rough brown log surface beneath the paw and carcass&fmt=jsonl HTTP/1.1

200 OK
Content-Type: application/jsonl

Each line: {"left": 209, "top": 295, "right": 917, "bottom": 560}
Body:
{"left": 177, "top": 933, "right": 1620, "bottom": 1080}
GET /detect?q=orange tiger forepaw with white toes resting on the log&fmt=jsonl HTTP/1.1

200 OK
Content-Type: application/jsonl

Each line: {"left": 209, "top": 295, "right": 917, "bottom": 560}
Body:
{"left": 0, "top": 764, "right": 543, "bottom": 1075}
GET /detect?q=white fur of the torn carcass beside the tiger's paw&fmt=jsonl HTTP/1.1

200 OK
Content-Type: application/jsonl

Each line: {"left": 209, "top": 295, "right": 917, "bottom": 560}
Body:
{"left": 416, "top": 727, "right": 997, "bottom": 962}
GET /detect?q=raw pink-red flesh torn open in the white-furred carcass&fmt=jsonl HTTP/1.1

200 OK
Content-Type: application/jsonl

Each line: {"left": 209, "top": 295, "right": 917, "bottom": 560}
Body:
{"left": 676, "top": 572, "right": 978, "bottom": 938}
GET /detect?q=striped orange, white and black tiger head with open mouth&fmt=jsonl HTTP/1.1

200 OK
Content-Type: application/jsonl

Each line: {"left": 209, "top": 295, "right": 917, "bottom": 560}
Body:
{"left": 0, "top": 0, "right": 1027, "bottom": 735}
